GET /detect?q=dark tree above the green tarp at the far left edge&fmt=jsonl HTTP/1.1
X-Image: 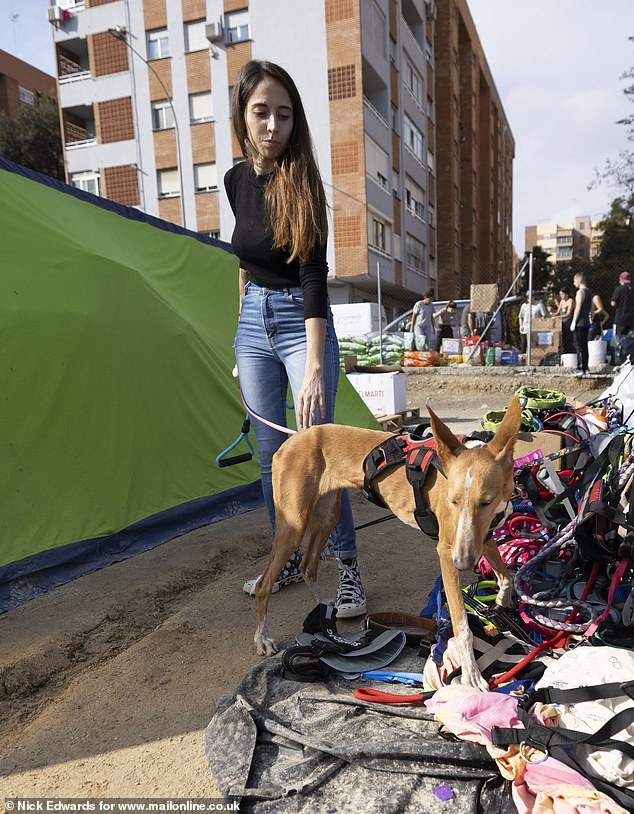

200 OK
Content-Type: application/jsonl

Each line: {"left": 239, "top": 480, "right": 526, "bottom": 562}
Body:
{"left": 0, "top": 94, "right": 64, "bottom": 181}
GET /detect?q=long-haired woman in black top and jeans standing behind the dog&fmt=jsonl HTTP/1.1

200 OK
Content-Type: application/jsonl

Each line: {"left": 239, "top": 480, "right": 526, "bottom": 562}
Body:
{"left": 225, "top": 60, "right": 366, "bottom": 617}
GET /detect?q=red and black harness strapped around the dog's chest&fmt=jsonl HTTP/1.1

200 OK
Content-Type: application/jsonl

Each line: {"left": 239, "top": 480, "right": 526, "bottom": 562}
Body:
{"left": 362, "top": 432, "right": 445, "bottom": 540}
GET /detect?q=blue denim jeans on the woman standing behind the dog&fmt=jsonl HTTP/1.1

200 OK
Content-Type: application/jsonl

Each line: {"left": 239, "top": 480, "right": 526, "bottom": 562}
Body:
{"left": 235, "top": 283, "right": 357, "bottom": 559}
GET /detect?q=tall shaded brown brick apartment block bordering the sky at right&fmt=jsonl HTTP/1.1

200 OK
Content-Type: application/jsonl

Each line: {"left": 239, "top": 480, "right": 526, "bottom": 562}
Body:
{"left": 435, "top": 0, "right": 515, "bottom": 297}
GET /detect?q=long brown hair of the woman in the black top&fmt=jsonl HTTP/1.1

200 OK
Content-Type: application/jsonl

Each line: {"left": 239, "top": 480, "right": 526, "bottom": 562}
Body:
{"left": 231, "top": 60, "right": 328, "bottom": 263}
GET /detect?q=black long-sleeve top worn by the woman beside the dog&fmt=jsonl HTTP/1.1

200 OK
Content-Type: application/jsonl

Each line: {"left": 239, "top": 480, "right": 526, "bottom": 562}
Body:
{"left": 225, "top": 161, "right": 328, "bottom": 319}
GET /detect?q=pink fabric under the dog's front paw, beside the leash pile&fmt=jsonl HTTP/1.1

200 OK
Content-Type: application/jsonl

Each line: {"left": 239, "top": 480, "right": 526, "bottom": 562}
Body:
{"left": 425, "top": 684, "right": 627, "bottom": 814}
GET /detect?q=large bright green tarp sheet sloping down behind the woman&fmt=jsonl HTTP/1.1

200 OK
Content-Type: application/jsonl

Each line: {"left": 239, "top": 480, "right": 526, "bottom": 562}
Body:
{"left": 0, "top": 164, "right": 376, "bottom": 566}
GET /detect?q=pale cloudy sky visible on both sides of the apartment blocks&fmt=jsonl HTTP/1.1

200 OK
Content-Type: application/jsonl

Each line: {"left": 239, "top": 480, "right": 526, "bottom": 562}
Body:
{"left": 0, "top": 0, "right": 634, "bottom": 255}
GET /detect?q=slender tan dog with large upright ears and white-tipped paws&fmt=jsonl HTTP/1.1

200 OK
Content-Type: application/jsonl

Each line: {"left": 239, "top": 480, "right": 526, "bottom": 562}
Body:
{"left": 254, "top": 399, "right": 520, "bottom": 690}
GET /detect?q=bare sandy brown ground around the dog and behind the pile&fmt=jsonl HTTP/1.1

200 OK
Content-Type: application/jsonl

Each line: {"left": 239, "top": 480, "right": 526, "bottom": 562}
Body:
{"left": 0, "top": 371, "right": 606, "bottom": 798}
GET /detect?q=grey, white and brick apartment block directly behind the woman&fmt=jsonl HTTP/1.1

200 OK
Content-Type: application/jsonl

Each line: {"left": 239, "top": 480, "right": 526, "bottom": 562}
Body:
{"left": 49, "top": 0, "right": 510, "bottom": 311}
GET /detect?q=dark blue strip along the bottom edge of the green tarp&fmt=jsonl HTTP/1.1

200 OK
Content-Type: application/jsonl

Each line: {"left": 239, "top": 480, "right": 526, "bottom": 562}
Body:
{"left": 0, "top": 480, "right": 264, "bottom": 613}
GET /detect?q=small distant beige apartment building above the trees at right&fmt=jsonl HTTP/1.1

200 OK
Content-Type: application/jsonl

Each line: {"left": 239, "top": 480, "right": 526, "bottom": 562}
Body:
{"left": 524, "top": 215, "right": 602, "bottom": 263}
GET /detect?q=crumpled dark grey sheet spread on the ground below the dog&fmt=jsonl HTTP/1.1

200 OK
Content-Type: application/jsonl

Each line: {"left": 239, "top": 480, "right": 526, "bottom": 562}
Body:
{"left": 205, "top": 649, "right": 514, "bottom": 814}
